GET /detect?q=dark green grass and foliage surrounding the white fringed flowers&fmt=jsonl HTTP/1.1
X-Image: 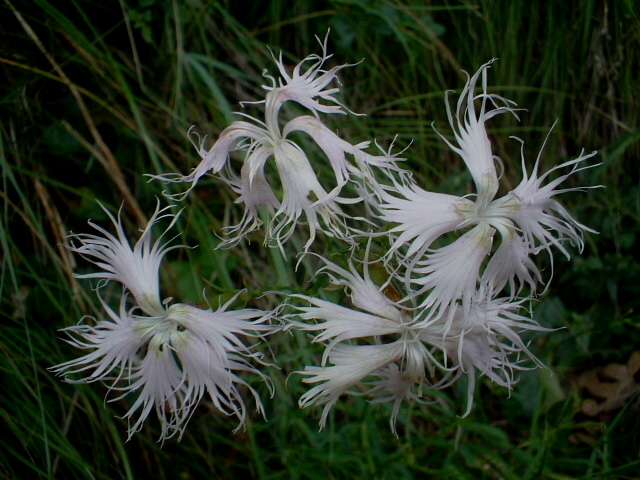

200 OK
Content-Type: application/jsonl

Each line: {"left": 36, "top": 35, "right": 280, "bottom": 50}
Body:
{"left": 0, "top": 0, "right": 640, "bottom": 480}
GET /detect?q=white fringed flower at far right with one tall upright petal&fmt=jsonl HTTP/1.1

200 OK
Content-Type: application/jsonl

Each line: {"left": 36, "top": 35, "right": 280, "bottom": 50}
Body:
{"left": 379, "top": 62, "right": 595, "bottom": 308}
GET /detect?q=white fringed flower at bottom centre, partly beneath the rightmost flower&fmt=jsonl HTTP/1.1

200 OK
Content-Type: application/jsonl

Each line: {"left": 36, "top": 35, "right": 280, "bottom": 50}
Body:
{"left": 287, "top": 254, "right": 546, "bottom": 433}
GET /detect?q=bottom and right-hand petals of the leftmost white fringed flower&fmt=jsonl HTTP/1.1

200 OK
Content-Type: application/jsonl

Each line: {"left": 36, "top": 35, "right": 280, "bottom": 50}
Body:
{"left": 131, "top": 299, "right": 273, "bottom": 438}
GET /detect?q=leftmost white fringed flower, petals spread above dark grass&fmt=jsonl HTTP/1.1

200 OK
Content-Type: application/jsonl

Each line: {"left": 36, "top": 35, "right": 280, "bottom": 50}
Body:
{"left": 51, "top": 202, "right": 272, "bottom": 440}
